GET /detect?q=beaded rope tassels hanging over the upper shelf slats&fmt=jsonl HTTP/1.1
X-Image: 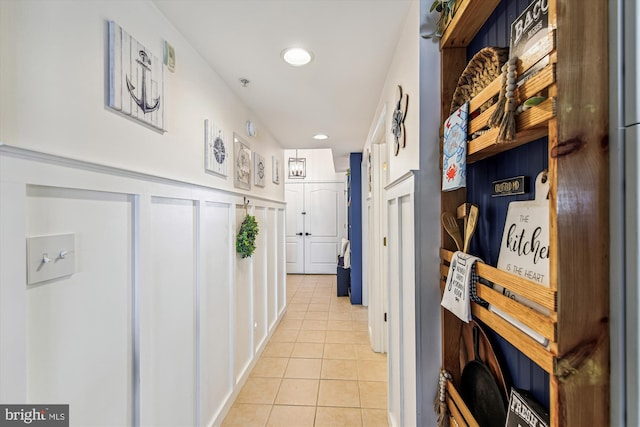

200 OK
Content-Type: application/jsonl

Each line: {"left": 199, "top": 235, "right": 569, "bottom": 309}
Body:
{"left": 487, "top": 57, "right": 518, "bottom": 143}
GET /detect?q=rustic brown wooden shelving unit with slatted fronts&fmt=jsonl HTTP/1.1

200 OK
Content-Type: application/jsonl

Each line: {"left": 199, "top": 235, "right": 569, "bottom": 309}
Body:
{"left": 440, "top": 0, "right": 609, "bottom": 427}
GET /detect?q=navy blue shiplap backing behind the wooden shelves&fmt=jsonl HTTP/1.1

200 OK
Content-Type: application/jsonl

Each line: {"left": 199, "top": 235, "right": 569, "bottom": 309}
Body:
{"left": 467, "top": 0, "right": 549, "bottom": 408}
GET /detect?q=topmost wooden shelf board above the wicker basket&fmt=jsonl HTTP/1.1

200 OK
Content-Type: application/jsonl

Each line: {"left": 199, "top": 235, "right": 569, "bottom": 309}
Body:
{"left": 440, "top": 0, "right": 500, "bottom": 49}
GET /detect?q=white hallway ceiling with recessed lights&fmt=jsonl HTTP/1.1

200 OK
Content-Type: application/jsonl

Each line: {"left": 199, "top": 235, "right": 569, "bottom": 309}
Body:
{"left": 154, "top": 0, "right": 418, "bottom": 171}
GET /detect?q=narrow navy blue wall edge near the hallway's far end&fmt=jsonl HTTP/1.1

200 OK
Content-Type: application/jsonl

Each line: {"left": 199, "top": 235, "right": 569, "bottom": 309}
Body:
{"left": 348, "top": 153, "right": 362, "bottom": 304}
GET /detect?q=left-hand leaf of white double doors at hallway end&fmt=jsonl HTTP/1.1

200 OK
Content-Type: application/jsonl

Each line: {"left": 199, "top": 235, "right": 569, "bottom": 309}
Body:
{"left": 284, "top": 183, "right": 305, "bottom": 274}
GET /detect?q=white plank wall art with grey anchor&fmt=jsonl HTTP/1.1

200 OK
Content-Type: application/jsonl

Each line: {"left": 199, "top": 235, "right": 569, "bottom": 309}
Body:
{"left": 108, "top": 21, "right": 166, "bottom": 132}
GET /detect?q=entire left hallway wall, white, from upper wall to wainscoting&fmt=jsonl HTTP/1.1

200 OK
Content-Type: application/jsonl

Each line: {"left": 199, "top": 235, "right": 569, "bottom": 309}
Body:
{"left": 0, "top": 0, "right": 286, "bottom": 426}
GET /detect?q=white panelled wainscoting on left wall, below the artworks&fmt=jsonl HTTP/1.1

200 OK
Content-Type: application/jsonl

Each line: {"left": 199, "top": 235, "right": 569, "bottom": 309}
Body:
{"left": 0, "top": 146, "right": 286, "bottom": 426}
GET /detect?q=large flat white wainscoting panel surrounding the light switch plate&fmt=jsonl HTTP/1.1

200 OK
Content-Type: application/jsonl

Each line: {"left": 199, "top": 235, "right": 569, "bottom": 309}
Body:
{"left": 23, "top": 186, "right": 133, "bottom": 426}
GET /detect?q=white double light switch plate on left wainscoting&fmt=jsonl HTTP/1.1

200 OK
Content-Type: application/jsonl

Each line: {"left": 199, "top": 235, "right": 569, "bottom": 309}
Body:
{"left": 27, "top": 233, "right": 76, "bottom": 285}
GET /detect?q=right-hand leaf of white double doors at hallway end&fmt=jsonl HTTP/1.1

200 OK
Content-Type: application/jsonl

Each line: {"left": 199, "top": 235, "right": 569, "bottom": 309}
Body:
{"left": 303, "top": 182, "right": 345, "bottom": 274}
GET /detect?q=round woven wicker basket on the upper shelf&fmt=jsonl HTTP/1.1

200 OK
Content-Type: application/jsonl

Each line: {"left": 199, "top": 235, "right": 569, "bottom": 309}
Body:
{"left": 449, "top": 47, "right": 509, "bottom": 115}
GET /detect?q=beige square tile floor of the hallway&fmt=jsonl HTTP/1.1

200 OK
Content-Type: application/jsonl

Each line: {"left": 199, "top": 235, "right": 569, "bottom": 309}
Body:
{"left": 222, "top": 275, "right": 388, "bottom": 427}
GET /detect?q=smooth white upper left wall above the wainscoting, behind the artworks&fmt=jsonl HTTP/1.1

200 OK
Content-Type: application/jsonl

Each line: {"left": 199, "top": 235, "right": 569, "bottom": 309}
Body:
{"left": 0, "top": 0, "right": 284, "bottom": 200}
